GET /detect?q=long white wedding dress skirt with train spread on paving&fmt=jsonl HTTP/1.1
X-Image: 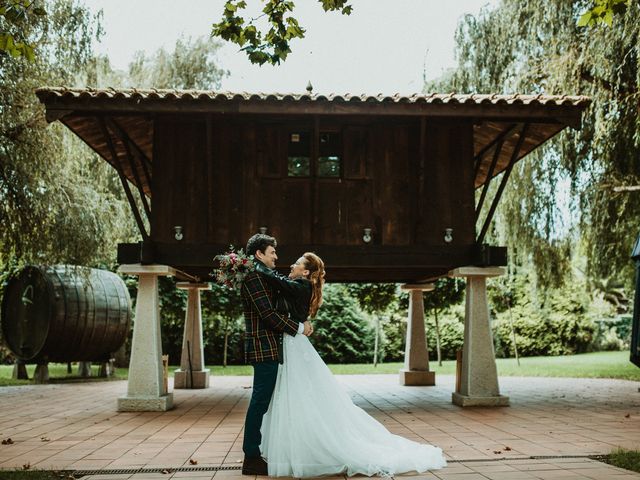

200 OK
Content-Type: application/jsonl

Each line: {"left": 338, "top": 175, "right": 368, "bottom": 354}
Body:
{"left": 260, "top": 335, "right": 447, "bottom": 478}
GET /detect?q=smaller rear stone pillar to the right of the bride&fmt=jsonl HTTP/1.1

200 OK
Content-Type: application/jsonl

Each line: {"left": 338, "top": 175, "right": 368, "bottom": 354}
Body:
{"left": 400, "top": 283, "right": 436, "bottom": 385}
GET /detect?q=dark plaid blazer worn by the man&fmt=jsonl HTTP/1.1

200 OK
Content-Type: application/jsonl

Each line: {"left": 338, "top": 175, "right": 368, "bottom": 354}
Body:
{"left": 241, "top": 272, "right": 299, "bottom": 363}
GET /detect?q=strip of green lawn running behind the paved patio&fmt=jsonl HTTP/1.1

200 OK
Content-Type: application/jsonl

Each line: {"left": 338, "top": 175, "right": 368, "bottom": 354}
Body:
{"left": 0, "top": 351, "right": 640, "bottom": 386}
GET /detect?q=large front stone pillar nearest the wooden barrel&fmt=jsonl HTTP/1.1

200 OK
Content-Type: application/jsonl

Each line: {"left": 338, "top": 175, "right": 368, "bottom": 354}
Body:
{"left": 118, "top": 264, "right": 176, "bottom": 412}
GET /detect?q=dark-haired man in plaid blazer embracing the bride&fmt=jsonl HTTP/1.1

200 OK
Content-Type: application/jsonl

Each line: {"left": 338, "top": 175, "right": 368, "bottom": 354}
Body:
{"left": 241, "top": 233, "right": 312, "bottom": 475}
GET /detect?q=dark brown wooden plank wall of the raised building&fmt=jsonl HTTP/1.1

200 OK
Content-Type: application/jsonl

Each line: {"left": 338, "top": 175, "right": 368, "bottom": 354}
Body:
{"left": 151, "top": 115, "right": 475, "bottom": 255}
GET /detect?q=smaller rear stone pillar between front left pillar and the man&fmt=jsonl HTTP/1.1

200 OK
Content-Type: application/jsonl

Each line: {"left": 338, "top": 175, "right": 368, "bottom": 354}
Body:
{"left": 173, "top": 282, "right": 211, "bottom": 388}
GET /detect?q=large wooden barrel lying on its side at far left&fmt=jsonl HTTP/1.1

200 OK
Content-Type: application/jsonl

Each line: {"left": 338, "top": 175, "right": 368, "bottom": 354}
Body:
{"left": 1, "top": 265, "right": 131, "bottom": 363}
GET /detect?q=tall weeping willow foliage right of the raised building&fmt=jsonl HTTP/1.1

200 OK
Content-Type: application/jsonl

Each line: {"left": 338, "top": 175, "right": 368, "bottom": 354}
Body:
{"left": 425, "top": 0, "right": 640, "bottom": 284}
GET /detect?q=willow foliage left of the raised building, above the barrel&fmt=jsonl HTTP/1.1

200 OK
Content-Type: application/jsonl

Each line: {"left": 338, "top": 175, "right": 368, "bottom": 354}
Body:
{"left": 0, "top": 0, "right": 138, "bottom": 271}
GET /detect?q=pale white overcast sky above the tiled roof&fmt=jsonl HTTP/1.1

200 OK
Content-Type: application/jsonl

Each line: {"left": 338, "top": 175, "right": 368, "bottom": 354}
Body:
{"left": 84, "top": 0, "right": 497, "bottom": 94}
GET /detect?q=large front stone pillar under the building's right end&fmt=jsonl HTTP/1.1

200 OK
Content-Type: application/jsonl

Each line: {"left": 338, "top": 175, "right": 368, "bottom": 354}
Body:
{"left": 449, "top": 267, "right": 509, "bottom": 407}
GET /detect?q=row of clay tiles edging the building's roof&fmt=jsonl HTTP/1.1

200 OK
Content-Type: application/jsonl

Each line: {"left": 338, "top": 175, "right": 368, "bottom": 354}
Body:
{"left": 36, "top": 87, "right": 591, "bottom": 107}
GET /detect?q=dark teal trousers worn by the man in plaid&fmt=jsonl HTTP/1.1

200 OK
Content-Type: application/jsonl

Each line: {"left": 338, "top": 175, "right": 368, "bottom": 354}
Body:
{"left": 242, "top": 360, "right": 279, "bottom": 457}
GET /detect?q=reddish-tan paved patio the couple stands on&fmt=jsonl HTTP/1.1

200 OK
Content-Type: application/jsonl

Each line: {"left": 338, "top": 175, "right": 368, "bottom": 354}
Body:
{"left": 0, "top": 375, "right": 640, "bottom": 480}
